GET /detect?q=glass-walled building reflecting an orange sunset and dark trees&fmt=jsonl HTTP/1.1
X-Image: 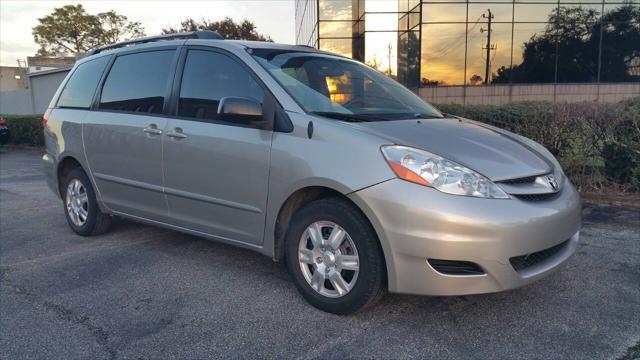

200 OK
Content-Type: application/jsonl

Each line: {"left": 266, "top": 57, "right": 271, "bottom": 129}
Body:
{"left": 295, "top": 0, "right": 640, "bottom": 103}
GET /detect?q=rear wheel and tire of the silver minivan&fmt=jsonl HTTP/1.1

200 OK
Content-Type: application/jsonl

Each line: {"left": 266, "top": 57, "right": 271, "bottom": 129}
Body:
{"left": 62, "top": 168, "right": 111, "bottom": 236}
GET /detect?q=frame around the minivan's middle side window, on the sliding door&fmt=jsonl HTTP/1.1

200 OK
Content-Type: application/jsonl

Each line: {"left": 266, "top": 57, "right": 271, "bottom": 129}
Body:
{"left": 90, "top": 45, "right": 182, "bottom": 117}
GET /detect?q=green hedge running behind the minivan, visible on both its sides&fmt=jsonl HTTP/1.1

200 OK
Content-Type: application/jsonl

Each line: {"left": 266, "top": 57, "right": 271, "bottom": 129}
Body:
{"left": 3, "top": 97, "right": 640, "bottom": 192}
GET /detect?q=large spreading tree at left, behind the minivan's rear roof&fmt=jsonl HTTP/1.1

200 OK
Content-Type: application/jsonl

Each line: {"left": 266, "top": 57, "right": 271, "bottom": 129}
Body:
{"left": 32, "top": 4, "right": 144, "bottom": 55}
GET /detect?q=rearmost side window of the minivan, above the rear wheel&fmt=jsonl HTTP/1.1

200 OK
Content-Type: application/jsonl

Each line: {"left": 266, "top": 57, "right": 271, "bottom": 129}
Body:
{"left": 58, "top": 56, "right": 110, "bottom": 109}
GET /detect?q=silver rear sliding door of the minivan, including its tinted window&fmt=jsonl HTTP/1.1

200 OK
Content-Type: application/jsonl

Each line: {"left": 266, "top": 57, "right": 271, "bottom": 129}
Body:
{"left": 83, "top": 49, "right": 176, "bottom": 222}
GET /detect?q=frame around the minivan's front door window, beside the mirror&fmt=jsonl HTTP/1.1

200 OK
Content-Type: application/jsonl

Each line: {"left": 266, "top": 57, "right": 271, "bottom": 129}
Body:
{"left": 167, "top": 45, "right": 282, "bottom": 131}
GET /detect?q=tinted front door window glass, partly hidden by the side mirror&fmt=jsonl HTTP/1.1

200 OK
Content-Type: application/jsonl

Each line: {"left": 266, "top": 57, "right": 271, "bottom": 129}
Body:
{"left": 178, "top": 50, "right": 264, "bottom": 121}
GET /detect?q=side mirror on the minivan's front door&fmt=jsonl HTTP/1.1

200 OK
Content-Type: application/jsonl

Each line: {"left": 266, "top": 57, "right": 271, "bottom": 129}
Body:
{"left": 218, "top": 96, "right": 270, "bottom": 130}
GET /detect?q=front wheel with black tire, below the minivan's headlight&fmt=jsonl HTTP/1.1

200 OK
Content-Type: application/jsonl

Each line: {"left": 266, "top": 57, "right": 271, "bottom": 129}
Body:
{"left": 285, "top": 198, "right": 387, "bottom": 315}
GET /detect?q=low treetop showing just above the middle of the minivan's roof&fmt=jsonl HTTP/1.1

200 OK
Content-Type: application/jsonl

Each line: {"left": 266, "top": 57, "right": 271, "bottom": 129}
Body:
{"left": 162, "top": 17, "right": 273, "bottom": 42}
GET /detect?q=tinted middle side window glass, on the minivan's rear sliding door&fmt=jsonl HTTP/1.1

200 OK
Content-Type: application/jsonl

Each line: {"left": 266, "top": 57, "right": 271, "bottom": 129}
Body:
{"left": 100, "top": 50, "right": 175, "bottom": 114}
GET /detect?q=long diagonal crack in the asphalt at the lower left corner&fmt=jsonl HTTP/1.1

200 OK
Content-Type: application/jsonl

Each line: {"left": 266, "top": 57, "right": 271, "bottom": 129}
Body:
{"left": 0, "top": 276, "right": 118, "bottom": 360}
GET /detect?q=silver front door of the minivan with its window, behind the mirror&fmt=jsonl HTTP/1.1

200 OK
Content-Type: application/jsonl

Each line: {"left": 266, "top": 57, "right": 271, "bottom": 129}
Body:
{"left": 164, "top": 49, "right": 272, "bottom": 245}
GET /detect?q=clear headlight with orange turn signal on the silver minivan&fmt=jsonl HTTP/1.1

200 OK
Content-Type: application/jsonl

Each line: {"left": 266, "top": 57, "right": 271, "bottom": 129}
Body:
{"left": 382, "top": 145, "right": 509, "bottom": 199}
